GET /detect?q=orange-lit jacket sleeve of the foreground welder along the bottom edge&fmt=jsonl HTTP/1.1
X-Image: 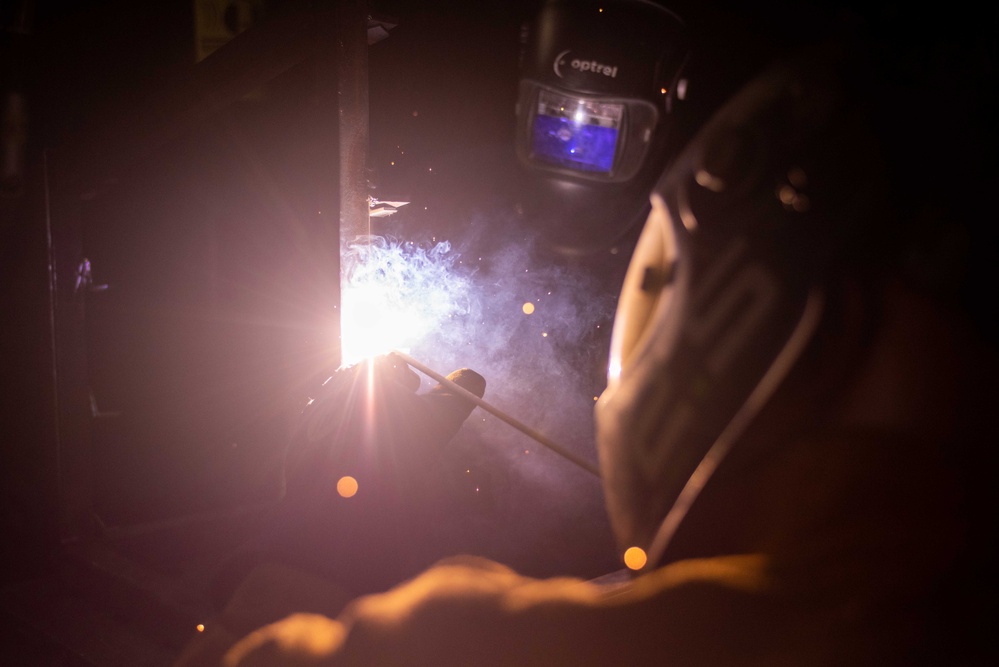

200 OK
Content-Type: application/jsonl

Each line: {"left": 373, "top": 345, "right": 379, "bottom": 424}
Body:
{"left": 225, "top": 556, "right": 775, "bottom": 667}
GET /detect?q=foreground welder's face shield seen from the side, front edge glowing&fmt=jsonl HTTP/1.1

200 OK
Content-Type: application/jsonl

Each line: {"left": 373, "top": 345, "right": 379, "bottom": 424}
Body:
{"left": 595, "top": 44, "right": 884, "bottom": 567}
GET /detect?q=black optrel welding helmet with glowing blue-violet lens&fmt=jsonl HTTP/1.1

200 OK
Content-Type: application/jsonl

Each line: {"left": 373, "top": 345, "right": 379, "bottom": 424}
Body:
{"left": 515, "top": 0, "right": 688, "bottom": 255}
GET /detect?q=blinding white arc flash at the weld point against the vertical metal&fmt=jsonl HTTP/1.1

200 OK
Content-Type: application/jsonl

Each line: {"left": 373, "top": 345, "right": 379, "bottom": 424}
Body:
{"left": 340, "top": 236, "right": 471, "bottom": 365}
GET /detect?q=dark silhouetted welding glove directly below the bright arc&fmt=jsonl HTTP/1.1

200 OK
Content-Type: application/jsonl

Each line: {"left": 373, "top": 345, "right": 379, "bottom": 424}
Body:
{"left": 214, "top": 354, "right": 485, "bottom": 606}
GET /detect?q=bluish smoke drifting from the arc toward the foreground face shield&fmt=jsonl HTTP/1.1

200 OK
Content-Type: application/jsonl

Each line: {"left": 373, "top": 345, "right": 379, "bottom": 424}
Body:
{"left": 342, "top": 214, "right": 623, "bottom": 576}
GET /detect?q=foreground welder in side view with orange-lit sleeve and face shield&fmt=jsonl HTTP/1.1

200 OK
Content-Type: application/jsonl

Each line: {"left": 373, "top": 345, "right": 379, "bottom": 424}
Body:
{"left": 176, "top": 1, "right": 997, "bottom": 667}
